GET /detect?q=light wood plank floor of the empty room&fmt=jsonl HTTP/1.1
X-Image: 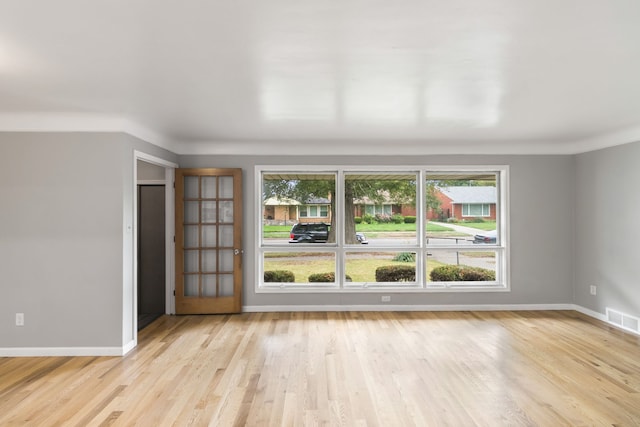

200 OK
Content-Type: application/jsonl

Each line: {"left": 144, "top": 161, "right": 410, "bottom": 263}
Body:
{"left": 0, "top": 312, "right": 640, "bottom": 427}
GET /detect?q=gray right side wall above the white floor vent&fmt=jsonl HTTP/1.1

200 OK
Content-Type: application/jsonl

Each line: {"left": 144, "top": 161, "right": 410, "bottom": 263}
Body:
{"left": 574, "top": 142, "right": 640, "bottom": 317}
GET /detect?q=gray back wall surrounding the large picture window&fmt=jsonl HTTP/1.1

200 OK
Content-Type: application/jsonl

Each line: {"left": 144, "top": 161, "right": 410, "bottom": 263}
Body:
{"left": 179, "top": 156, "right": 575, "bottom": 306}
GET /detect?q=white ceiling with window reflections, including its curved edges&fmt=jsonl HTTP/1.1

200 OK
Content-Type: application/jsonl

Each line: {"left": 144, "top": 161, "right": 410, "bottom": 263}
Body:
{"left": 0, "top": 0, "right": 640, "bottom": 154}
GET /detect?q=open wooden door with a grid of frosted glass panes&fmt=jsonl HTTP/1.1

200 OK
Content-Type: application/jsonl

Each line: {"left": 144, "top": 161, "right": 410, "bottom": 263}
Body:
{"left": 176, "top": 169, "right": 243, "bottom": 314}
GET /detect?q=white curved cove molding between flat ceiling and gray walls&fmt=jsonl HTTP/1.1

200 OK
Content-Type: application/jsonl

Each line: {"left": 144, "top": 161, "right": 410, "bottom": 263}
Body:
{"left": 0, "top": 113, "right": 640, "bottom": 156}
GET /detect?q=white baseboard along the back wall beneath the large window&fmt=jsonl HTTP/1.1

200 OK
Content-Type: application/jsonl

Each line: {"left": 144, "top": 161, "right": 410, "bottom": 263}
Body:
{"left": 242, "top": 304, "right": 575, "bottom": 313}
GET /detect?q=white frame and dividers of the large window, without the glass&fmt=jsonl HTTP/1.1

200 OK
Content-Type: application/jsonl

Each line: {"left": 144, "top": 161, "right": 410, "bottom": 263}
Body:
{"left": 254, "top": 165, "right": 511, "bottom": 293}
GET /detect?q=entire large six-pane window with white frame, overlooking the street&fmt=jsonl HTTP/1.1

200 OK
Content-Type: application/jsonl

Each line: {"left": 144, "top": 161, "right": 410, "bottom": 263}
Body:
{"left": 256, "top": 166, "right": 509, "bottom": 292}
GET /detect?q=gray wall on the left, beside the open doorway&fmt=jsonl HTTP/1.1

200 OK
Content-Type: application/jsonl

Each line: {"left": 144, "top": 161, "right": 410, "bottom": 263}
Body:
{"left": 0, "top": 133, "right": 176, "bottom": 348}
